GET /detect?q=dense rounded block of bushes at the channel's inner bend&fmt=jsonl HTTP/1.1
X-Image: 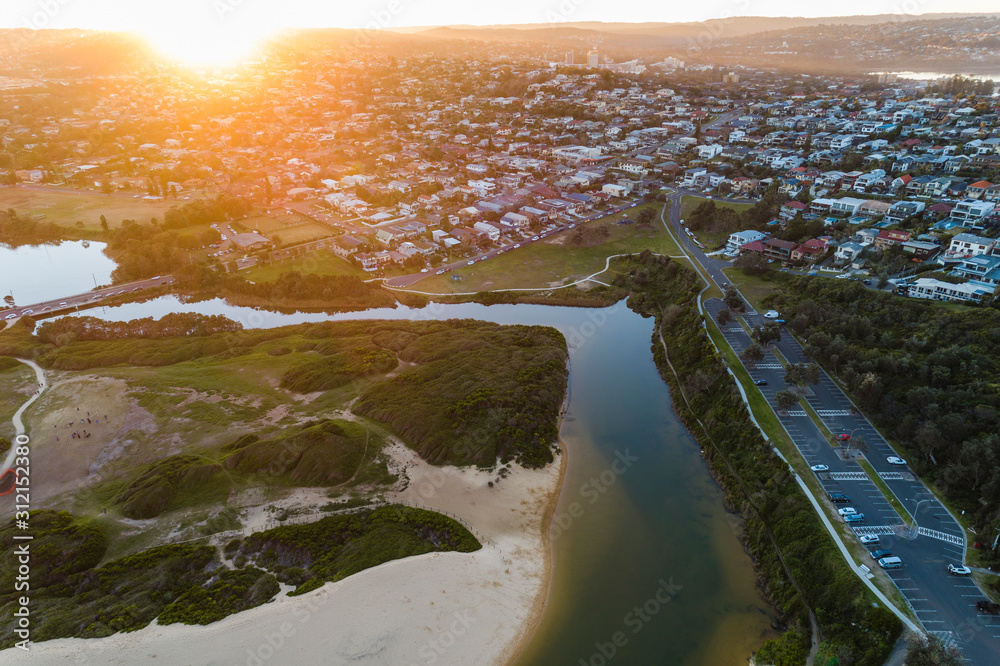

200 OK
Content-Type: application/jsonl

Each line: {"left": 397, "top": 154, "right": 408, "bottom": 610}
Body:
{"left": 354, "top": 322, "right": 567, "bottom": 467}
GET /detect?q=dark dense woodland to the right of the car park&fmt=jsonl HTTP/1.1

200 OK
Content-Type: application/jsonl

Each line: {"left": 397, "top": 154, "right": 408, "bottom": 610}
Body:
{"left": 765, "top": 277, "right": 1000, "bottom": 532}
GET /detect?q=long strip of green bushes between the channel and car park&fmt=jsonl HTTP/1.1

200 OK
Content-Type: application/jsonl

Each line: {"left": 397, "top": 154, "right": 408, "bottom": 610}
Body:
{"left": 613, "top": 252, "right": 902, "bottom": 666}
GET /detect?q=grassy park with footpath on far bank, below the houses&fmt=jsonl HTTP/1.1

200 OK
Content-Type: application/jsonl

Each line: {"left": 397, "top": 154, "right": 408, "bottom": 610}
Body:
{"left": 411, "top": 203, "right": 680, "bottom": 293}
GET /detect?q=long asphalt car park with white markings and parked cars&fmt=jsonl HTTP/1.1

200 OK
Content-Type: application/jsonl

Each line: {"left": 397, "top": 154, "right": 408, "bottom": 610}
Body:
{"left": 705, "top": 299, "right": 1000, "bottom": 664}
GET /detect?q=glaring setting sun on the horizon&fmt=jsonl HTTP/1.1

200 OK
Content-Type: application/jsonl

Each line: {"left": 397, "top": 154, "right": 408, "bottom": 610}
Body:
{"left": 145, "top": 26, "right": 267, "bottom": 67}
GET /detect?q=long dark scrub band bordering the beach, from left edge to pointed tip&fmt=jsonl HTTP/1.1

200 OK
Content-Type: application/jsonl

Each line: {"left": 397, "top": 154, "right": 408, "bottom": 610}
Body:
{"left": 0, "top": 506, "right": 474, "bottom": 649}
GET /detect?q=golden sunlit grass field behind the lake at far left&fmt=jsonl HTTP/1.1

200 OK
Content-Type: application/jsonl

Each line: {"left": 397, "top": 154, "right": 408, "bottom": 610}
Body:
{"left": 0, "top": 187, "right": 176, "bottom": 231}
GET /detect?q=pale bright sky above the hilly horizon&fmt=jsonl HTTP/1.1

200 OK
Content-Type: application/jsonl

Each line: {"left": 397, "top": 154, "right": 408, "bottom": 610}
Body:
{"left": 0, "top": 0, "right": 998, "bottom": 60}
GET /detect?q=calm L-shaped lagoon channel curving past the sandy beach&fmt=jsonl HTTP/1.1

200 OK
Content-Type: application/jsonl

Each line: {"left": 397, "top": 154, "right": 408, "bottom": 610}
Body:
{"left": 54, "top": 296, "right": 777, "bottom": 666}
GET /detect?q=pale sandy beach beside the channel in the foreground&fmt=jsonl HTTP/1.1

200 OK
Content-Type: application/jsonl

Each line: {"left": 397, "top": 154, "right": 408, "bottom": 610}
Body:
{"left": 0, "top": 444, "right": 565, "bottom": 666}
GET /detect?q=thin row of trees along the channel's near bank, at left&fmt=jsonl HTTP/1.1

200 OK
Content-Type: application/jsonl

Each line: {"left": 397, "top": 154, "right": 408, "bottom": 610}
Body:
{"left": 35, "top": 312, "right": 243, "bottom": 347}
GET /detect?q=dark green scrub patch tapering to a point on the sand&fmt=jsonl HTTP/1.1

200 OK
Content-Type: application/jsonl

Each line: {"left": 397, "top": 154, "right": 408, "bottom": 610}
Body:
{"left": 226, "top": 505, "right": 482, "bottom": 594}
